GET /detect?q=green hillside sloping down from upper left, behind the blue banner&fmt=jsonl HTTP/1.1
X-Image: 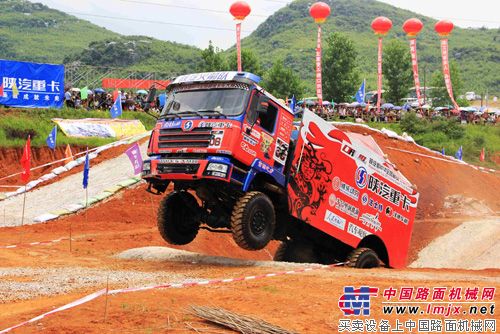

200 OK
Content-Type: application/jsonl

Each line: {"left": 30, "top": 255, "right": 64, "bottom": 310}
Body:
{"left": 0, "top": 0, "right": 201, "bottom": 75}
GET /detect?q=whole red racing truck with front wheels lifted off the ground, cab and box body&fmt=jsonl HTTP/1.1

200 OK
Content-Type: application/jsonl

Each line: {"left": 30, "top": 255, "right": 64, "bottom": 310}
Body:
{"left": 142, "top": 72, "right": 418, "bottom": 268}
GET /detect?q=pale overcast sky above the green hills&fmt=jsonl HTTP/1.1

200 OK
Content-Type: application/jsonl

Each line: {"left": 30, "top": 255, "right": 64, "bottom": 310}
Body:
{"left": 30, "top": 0, "right": 500, "bottom": 49}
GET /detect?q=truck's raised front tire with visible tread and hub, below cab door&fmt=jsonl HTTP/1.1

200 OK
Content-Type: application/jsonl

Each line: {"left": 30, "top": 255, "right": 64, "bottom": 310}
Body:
{"left": 231, "top": 191, "right": 276, "bottom": 250}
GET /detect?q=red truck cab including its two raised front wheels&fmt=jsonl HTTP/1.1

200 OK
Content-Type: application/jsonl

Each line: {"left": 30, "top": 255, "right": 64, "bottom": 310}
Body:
{"left": 142, "top": 72, "right": 293, "bottom": 250}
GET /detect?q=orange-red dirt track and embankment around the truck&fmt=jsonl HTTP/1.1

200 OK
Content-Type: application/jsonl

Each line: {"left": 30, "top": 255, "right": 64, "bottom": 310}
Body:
{"left": 0, "top": 126, "right": 500, "bottom": 333}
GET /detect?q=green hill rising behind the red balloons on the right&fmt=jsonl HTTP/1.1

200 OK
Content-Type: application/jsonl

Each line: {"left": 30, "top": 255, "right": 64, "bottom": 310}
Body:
{"left": 242, "top": 0, "right": 500, "bottom": 94}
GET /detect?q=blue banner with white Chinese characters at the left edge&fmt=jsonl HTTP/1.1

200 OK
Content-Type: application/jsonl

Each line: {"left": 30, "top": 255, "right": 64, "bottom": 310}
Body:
{"left": 0, "top": 59, "right": 64, "bottom": 108}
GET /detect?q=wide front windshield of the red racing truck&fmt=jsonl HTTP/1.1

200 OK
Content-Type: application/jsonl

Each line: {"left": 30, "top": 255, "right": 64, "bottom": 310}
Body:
{"left": 160, "top": 88, "right": 250, "bottom": 117}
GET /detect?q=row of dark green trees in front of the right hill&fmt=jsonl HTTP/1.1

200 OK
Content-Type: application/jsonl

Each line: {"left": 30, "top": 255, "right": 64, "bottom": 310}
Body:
{"left": 199, "top": 32, "right": 467, "bottom": 106}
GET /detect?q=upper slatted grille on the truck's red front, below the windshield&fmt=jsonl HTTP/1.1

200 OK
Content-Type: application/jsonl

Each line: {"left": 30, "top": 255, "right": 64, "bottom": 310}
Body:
{"left": 158, "top": 128, "right": 212, "bottom": 148}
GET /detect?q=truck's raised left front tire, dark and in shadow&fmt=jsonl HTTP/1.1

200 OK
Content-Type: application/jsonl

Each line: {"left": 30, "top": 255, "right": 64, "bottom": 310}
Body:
{"left": 158, "top": 191, "right": 200, "bottom": 245}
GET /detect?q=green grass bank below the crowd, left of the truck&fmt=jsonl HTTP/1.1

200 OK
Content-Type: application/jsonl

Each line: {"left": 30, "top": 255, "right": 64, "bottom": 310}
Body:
{"left": 0, "top": 108, "right": 156, "bottom": 147}
